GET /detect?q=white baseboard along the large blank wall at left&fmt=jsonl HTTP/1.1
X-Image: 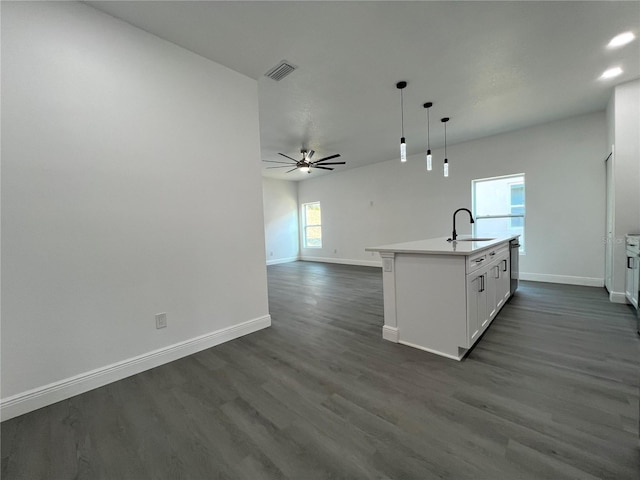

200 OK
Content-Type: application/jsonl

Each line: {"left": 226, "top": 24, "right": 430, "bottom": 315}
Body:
{"left": 0, "top": 315, "right": 271, "bottom": 421}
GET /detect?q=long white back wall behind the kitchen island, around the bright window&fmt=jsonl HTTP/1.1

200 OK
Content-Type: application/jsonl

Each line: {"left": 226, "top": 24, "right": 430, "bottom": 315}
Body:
{"left": 298, "top": 112, "right": 607, "bottom": 285}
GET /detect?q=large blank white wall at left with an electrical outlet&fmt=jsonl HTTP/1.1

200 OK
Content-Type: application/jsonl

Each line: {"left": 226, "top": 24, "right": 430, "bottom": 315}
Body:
{"left": 2, "top": 2, "right": 270, "bottom": 418}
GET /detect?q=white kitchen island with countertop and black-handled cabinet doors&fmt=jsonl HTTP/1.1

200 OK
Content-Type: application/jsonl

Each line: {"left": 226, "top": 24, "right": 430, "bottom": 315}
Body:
{"left": 366, "top": 235, "right": 517, "bottom": 360}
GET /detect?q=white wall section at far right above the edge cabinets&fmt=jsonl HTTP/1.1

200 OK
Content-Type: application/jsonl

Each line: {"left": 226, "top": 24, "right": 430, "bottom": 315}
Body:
{"left": 607, "top": 80, "right": 640, "bottom": 301}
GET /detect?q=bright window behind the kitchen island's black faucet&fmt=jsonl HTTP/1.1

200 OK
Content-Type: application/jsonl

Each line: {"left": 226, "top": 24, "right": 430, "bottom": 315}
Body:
{"left": 471, "top": 173, "right": 525, "bottom": 253}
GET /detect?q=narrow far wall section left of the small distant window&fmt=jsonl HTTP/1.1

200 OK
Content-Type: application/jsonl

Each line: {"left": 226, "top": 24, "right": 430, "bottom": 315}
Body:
{"left": 262, "top": 178, "right": 300, "bottom": 265}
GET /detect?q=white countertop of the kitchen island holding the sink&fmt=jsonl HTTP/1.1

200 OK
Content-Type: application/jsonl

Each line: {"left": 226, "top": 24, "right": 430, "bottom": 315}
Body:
{"left": 365, "top": 235, "right": 519, "bottom": 255}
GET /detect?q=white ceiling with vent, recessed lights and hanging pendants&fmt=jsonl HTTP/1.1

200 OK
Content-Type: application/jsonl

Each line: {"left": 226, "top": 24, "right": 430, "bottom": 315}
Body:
{"left": 86, "top": 1, "right": 640, "bottom": 180}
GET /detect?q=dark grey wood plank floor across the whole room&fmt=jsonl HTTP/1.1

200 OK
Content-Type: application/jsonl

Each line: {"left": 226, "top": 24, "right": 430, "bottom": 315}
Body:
{"left": 1, "top": 262, "right": 640, "bottom": 480}
